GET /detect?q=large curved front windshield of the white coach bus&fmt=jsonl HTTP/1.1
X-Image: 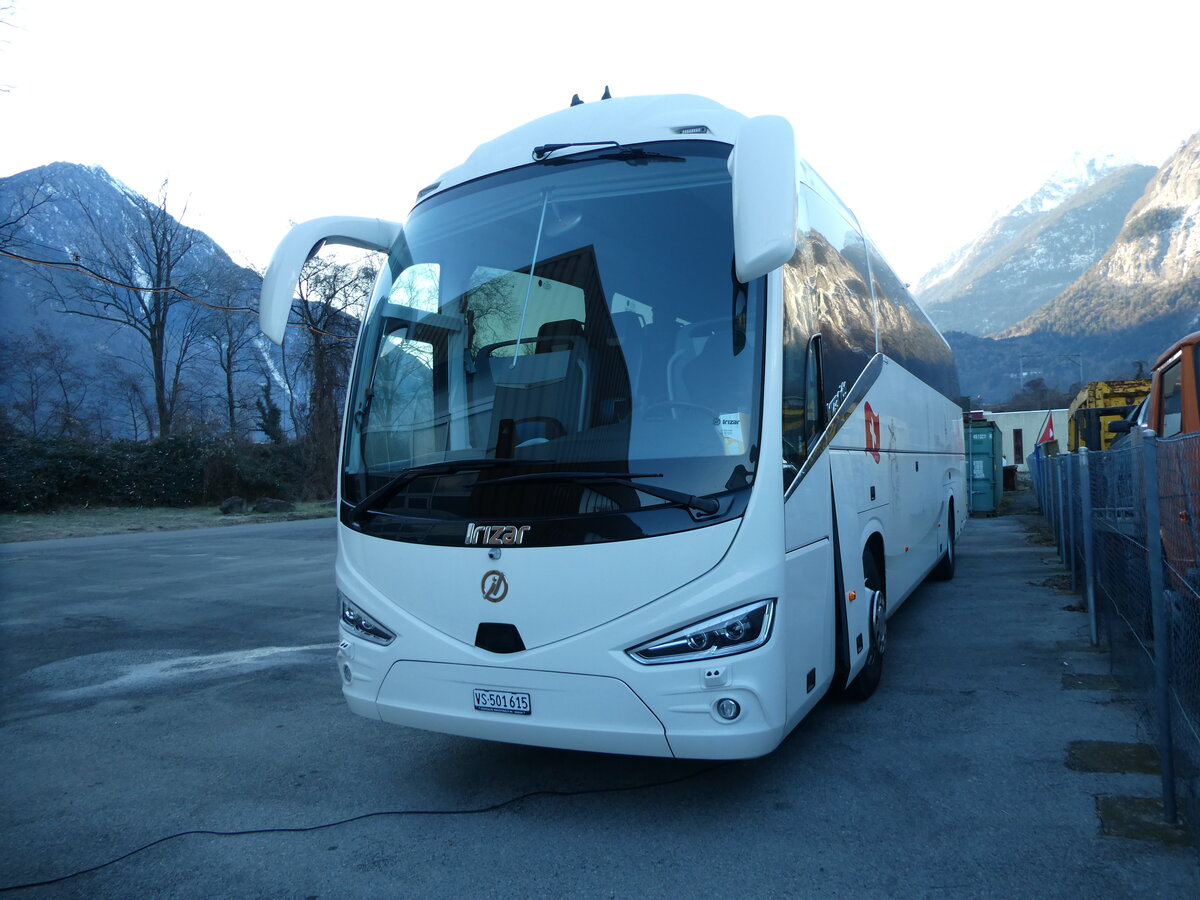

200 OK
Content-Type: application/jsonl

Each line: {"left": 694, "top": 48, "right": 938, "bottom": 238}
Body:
{"left": 342, "top": 142, "right": 764, "bottom": 544}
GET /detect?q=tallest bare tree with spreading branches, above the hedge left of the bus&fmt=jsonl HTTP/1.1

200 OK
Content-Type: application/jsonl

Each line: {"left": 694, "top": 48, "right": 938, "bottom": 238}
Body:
{"left": 41, "top": 182, "right": 204, "bottom": 437}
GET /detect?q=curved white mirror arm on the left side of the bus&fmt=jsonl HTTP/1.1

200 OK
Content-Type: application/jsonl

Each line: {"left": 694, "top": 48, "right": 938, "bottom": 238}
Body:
{"left": 258, "top": 216, "right": 403, "bottom": 344}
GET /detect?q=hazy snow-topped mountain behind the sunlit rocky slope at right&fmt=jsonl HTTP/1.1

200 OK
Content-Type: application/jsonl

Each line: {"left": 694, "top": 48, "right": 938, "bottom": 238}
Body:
{"left": 916, "top": 155, "right": 1154, "bottom": 335}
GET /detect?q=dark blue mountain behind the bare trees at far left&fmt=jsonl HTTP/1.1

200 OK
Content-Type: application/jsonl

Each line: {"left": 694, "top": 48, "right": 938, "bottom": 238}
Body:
{"left": 0, "top": 162, "right": 265, "bottom": 438}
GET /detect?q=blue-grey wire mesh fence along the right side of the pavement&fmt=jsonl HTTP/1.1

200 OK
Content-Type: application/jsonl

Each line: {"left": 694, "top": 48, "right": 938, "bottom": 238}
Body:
{"left": 1031, "top": 428, "right": 1200, "bottom": 833}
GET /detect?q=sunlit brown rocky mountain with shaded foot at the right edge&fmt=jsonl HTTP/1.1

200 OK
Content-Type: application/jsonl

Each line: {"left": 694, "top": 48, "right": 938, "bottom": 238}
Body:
{"left": 946, "top": 133, "right": 1200, "bottom": 403}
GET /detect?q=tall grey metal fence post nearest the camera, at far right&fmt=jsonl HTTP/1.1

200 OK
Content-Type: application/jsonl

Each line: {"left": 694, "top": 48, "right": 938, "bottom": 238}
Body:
{"left": 1142, "top": 428, "right": 1176, "bottom": 822}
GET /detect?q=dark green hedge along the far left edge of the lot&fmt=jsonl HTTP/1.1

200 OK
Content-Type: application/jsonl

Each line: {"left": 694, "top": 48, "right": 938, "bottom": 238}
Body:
{"left": 0, "top": 432, "right": 332, "bottom": 512}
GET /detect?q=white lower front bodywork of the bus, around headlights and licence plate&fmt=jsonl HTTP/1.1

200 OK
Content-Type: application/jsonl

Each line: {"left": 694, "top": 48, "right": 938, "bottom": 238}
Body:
{"left": 337, "top": 513, "right": 800, "bottom": 758}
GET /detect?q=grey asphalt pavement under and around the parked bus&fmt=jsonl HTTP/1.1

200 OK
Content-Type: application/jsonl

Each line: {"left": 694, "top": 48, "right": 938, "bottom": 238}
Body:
{"left": 0, "top": 497, "right": 1200, "bottom": 900}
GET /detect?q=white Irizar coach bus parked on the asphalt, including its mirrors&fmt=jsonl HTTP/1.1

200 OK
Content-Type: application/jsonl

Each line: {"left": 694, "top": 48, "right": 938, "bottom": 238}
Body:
{"left": 260, "top": 96, "right": 966, "bottom": 758}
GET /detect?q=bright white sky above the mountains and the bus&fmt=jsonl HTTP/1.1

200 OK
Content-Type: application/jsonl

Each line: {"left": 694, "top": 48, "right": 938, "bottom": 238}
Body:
{"left": 0, "top": 0, "right": 1200, "bottom": 283}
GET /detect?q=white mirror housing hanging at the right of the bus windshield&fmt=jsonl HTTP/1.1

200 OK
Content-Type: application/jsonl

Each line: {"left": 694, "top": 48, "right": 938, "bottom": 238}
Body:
{"left": 730, "top": 115, "right": 799, "bottom": 283}
